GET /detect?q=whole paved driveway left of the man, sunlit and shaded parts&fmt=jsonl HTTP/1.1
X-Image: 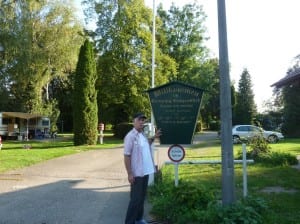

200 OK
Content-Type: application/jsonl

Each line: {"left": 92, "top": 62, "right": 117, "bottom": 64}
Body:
{"left": 0, "top": 148, "right": 129, "bottom": 224}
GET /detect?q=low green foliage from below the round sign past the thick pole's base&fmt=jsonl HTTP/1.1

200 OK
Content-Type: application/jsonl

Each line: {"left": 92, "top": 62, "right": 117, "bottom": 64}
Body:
{"left": 149, "top": 181, "right": 267, "bottom": 224}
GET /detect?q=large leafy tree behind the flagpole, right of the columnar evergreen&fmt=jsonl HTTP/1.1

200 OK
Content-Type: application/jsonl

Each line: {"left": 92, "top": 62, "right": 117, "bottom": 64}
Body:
{"left": 88, "top": 0, "right": 176, "bottom": 125}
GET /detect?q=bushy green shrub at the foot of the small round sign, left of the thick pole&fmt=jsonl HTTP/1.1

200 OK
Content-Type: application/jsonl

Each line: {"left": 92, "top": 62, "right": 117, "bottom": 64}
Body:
{"left": 149, "top": 180, "right": 214, "bottom": 224}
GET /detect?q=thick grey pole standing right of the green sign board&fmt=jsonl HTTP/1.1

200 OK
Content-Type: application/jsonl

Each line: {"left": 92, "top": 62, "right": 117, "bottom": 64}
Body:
{"left": 218, "top": 0, "right": 235, "bottom": 205}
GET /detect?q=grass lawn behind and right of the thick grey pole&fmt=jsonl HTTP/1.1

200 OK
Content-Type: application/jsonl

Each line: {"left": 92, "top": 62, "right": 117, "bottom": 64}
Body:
{"left": 162, "top": 139, "right": 300, "bottom": 224}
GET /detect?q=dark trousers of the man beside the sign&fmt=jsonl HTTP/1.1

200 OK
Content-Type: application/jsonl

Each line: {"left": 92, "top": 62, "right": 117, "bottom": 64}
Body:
{"left": 125, "top": 175, "right": 149, "bottom": 224}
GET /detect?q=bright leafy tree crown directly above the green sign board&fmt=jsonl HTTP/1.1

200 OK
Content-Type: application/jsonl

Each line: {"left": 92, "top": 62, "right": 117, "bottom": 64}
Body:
{"left": 157, "top": 3, "right": 209, "bottom": 84}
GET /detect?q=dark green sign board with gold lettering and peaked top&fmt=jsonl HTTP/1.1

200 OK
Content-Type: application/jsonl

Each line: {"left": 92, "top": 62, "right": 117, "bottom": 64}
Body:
{"left": 148, "top": 82, "right": 203, "bottom": 144}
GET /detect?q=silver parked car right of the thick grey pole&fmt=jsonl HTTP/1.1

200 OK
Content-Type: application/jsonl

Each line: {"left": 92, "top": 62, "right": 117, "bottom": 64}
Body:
{"left": 232, "top": 125, "right": 284, "bottom": 144}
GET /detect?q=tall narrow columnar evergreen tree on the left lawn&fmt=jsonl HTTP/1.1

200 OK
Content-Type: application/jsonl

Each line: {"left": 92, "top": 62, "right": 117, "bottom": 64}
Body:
{"left": 73, "top": 40, "right": 98, "bottom": 145}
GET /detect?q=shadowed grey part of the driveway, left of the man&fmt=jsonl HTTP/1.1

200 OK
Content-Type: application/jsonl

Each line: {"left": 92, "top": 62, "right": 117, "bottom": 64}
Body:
{"left": 0, "top": 179, "right": 129, "bottom": 224}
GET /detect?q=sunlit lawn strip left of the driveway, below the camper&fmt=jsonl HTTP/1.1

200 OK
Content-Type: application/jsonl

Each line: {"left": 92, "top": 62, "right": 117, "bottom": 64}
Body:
{"left": 0, "top": 134, "right": 122, "bottom": 173}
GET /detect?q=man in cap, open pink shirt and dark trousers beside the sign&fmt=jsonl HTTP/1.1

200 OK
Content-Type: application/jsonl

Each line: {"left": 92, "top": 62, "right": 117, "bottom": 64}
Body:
{"left": 124, "top": 113, "right": 160, "bottom": 224}
